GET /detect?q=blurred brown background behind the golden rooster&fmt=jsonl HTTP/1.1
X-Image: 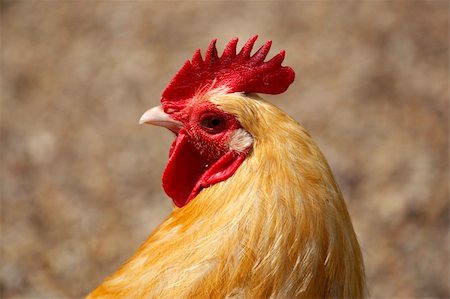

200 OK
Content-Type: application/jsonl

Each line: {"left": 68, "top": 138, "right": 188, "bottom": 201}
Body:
{"left": 0, "top": 1, "right": 450, "bottom": 298}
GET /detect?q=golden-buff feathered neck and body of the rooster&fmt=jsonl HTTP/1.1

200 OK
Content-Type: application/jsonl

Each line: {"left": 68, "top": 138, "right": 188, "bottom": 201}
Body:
{"left": 88, "top": 36, "right": 365, "bottom": 298}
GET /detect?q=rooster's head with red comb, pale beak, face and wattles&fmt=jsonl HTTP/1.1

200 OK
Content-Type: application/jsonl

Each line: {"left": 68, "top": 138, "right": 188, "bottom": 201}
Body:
{"left": 139, "top": 36, "right": 295, "bottom": 207}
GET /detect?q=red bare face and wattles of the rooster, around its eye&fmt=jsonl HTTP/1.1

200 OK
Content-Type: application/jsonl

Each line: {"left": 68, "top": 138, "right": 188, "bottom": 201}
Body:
{"left": 162, "top": 101, "right": 247, "bottom": 208}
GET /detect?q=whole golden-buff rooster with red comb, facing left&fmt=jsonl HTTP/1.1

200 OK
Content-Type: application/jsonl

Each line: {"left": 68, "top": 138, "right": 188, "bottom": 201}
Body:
{"left": 88, "top": 36, "right": 366, "bottom": 298}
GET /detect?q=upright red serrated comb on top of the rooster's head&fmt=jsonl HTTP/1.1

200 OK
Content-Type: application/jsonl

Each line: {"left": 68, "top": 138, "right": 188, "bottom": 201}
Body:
{"left": 161, "top": 35, "right": 295, "bottom": 108}
